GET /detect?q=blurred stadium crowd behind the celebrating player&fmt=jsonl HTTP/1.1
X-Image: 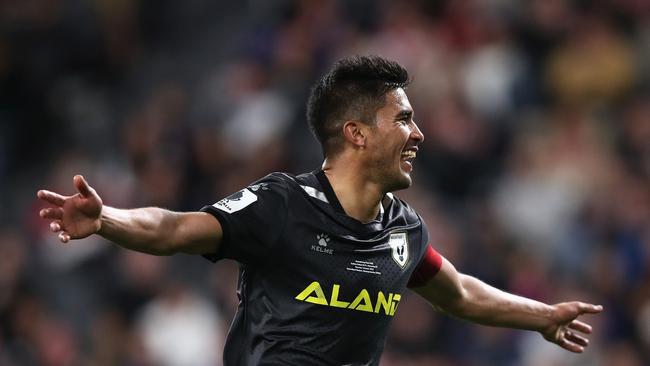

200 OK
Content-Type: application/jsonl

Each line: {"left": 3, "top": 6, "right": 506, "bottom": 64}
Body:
{"left": 0, "top": 0, "right": 650, "bottom": 366}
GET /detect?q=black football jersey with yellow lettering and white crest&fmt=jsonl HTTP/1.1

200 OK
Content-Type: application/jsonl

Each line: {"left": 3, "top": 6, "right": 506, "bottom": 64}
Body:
{"left": 202, "top": 171, "right": 428, "bottom": 366}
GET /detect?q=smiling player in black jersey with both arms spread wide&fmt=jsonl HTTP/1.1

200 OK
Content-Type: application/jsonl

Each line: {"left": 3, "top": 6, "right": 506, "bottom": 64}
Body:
{"left": 38, "top": 57, "right": 602, "bottom": 366}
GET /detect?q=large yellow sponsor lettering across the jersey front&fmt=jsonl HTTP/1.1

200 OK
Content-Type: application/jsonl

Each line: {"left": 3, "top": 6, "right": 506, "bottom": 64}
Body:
{"left": 296, "top": 281, "right": 402, "bottom": 316}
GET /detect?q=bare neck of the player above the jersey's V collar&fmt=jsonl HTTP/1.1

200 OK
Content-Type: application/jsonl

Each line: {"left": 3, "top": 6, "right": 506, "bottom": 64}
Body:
{"left": 323, "top": 159, "right": 385, "bottom": 223}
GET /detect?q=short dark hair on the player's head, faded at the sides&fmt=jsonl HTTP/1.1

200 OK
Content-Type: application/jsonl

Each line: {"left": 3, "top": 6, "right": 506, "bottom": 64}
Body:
{"left": 307, "top": 56, "right": 409, "bottom": 157}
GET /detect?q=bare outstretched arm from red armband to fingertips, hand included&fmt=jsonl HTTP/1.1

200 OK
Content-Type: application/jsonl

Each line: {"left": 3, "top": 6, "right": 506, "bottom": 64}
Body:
{"left": 413, "top": 259, "right": 602, "bottom": 353}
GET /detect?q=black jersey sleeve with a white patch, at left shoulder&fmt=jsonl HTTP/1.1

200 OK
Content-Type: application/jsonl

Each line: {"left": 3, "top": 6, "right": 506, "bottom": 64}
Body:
{"left": 201, "top": 175, "right": 288, "bottom": 264}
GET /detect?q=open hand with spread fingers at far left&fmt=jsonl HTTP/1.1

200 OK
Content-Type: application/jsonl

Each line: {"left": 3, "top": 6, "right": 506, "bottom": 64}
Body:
{"left": 36, "top": 175, "right": 103, "bottom": 243}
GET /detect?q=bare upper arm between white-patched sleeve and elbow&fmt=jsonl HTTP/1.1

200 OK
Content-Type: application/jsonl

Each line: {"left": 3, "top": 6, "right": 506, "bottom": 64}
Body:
{"left": 172, "top": 212, "right": 223, "bottom": 254}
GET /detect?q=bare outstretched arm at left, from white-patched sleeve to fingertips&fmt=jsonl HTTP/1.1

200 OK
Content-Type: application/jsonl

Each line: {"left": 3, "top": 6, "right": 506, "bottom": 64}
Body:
{"left": 37, "top": 175, "right": 222, "bottom": 255}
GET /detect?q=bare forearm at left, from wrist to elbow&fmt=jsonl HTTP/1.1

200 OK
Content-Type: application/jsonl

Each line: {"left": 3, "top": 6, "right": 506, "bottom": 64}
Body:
{"left": 97, "top": 206, "right": 178, "bottom": 255}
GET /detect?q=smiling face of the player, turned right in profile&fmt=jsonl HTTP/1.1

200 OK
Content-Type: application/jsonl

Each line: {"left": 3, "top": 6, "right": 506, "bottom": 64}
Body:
{"left": 367, "top": 88, "right": 424, "bottom": 192}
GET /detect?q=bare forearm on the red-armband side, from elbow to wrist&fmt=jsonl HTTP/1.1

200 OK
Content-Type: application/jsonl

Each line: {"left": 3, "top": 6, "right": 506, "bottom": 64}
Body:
{"left": 445, "top": 275, "right": 553, "bottom": 331}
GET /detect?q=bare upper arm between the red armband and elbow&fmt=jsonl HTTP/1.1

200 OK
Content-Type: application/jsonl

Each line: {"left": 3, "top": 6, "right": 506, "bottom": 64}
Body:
{"left": 413, "top": 258, "right": 465, "bottom": 311}
